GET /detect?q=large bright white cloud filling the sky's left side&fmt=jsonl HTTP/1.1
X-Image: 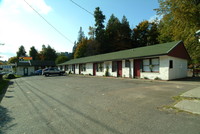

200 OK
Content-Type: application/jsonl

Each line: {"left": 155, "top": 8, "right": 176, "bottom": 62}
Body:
{"left": 0, "top": 0, "right": 52, "bottom": 60}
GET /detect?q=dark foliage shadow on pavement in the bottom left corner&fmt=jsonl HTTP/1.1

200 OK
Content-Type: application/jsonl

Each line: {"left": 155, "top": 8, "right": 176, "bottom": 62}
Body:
{"left": 0, "top": 105, "right": 15, "bottom": 134}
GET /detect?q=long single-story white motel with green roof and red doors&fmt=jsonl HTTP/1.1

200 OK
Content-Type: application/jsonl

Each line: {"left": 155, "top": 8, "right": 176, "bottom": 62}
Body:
{"left": 58, "top": 41, "right": 190, "bottom": 80}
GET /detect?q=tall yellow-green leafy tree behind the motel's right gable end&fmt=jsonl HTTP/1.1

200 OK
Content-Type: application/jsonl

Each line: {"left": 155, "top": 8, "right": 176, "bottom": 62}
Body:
{"left": 156, "top": 0, "right": 200, "bottom": 62}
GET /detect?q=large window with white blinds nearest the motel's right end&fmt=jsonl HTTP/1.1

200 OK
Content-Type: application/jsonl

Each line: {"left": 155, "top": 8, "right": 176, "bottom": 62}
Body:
{"left": 143, "top": 58, "right": 159, "bottom": 72}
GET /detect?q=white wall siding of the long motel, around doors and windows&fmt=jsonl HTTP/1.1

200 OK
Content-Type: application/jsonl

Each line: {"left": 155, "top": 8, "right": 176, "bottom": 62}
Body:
{"left": 59, "top": 55, "right": 187, "bottom": 80}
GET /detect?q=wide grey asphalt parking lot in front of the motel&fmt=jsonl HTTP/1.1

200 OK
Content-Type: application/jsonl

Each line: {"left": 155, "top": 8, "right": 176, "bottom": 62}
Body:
{"left": 0, "top": 76, "right": 200, "bottom": 134}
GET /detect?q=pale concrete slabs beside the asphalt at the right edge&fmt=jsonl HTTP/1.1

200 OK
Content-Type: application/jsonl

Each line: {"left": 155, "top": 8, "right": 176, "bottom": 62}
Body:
{"left": 175, "top": 87, "right": 200, "bottom": 115}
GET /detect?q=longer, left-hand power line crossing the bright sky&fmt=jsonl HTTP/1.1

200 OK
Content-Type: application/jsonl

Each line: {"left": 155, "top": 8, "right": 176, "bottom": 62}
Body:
{"left": 24, "top": 0, "right": 73, "bottom": 44}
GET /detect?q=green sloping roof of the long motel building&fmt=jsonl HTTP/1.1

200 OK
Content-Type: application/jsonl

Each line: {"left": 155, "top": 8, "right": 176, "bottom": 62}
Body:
{"left": 59, "top": 41, "right": 181, "bottom": 65}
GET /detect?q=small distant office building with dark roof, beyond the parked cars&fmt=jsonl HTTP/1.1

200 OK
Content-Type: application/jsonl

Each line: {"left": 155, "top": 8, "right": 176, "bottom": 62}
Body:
{"left": 16, "top": 60, "right": 55, "bottom": 76}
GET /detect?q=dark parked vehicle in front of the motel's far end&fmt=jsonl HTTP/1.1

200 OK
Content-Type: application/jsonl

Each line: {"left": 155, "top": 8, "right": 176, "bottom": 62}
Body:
{"left": 42, "top": 68, "right": 65, "bottom": 76}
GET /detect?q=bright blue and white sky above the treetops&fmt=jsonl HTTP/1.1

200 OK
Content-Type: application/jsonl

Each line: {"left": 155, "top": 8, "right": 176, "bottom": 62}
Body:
{"left": 0, "top": 0, "right": 159, "bottom": 60}
